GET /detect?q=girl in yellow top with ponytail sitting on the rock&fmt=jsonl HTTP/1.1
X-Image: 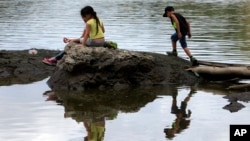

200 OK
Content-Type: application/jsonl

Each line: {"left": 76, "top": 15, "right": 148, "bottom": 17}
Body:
{"left": 43, "top": 6, "right": 117, "bottom": 65}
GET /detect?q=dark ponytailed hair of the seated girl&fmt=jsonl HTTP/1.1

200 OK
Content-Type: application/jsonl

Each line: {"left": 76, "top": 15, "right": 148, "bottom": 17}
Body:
{"left": 80, "top": 6, "right": 101, "bottom": 34}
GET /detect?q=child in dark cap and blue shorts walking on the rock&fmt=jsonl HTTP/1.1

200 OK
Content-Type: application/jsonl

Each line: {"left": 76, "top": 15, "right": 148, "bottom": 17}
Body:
{"left": 163, "top": 6, "right": 198, "bottom": 66}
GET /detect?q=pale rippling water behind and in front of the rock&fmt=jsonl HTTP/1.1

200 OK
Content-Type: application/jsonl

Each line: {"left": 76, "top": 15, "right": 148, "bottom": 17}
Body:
{"left": 0, "top": 0, "right": 250, "bottom": 141}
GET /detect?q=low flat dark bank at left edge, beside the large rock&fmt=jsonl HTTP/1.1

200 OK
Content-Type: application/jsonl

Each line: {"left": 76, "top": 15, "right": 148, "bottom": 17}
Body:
{"left": 0, "top": 49, "right": 58, "bottom": 86}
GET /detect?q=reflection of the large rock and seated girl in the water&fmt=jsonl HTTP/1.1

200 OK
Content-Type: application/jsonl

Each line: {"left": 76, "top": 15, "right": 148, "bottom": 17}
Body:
{"left": 44, "top": 88, "right": 160, "bottom": 141}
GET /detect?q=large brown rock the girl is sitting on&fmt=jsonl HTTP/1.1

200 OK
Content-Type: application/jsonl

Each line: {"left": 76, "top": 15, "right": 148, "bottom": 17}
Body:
{"left": 48, "top": 43, "right": 198, "bottom": 90}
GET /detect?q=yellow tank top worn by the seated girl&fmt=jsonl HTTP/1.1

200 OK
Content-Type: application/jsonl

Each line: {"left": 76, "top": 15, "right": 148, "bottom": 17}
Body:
{"left": 87, "top": 19, "right": 104, "bottom": 39}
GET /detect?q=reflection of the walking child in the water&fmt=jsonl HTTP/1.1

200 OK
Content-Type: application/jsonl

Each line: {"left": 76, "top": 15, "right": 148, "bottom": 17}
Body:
{"left": 164, "top": 88, "right": 196, "bottom": 139}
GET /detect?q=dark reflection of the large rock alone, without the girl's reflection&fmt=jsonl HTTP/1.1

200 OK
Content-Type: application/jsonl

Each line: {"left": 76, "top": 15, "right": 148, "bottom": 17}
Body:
{"left": 56, "top": 87, "right": 164, "bottom": 122}
